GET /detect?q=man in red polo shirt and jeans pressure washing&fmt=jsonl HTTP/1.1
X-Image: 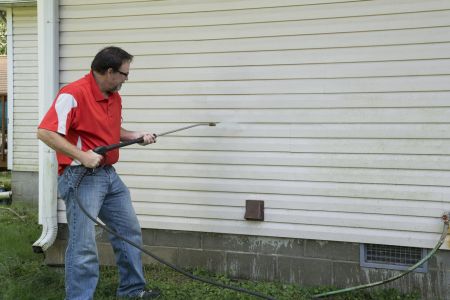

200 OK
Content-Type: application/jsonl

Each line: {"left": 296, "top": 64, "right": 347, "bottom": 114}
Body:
{"left": 37, "top": 47, "right": 159, "bottom": 300}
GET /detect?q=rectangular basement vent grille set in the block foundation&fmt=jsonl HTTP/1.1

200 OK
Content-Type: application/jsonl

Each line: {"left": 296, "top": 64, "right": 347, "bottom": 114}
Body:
{"left": 360, "top": 244, "right": 427, "bottom": 272}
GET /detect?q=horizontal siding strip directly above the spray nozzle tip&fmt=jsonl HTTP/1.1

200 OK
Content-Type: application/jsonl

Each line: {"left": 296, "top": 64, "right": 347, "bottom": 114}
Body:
{"left": 122, "top": 107, "right": 450, "bottom": 123}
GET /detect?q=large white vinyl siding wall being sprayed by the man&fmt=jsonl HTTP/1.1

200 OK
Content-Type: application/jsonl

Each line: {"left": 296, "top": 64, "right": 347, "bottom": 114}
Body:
{"left": 59, "top": 0, "right": 450, "bottom": 249}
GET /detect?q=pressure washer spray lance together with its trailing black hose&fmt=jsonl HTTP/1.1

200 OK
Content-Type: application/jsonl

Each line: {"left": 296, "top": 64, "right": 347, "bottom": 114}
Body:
{"left": 74, "top": 123, "right": 275, "bottom": 300}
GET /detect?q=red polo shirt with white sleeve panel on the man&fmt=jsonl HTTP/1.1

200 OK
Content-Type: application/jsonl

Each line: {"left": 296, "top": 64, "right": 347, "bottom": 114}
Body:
{"left": 39, "top": 71, "right": 122, "bottom": 174}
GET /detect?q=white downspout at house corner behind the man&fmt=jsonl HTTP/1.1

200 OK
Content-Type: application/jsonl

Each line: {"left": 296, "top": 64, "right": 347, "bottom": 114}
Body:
{"left": 33, "top": 0, "right": 59, "bottom": 253}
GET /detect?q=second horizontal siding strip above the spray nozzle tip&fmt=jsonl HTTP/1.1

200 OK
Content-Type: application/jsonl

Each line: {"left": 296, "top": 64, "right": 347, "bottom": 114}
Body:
{"left": 122, "top": 92, "right": 450, "bottom": 109}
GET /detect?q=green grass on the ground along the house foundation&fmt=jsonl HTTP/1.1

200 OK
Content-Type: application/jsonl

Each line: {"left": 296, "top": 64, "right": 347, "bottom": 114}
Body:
{"left": 0, "top": 203, "right": 419, "bottom": 300}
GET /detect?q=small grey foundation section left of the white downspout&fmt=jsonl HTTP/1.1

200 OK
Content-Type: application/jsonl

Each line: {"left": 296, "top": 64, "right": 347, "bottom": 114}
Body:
{"left": 11, "top": 171, "right": 39, "bottom": 206}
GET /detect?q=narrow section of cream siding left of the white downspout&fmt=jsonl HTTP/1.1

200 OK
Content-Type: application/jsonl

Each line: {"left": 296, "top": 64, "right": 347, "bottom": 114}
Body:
{"left": 12, "top": 6, "right": 39, "bottom": 172}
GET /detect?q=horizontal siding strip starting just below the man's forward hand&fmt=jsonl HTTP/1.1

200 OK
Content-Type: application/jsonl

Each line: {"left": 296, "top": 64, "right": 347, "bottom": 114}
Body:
{"left": 115, "top": 137, "right": 450, "bottom": 155}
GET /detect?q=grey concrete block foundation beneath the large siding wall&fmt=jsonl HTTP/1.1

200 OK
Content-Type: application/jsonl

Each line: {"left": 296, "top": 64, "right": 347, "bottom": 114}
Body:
{"left": 46, "top": 224, "right": 450, "bottom": 300}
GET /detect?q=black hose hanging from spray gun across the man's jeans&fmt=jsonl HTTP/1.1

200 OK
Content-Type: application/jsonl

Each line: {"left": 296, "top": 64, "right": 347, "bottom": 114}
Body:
{"left": 74, "top": 168, "right": 276, "bottom": 300}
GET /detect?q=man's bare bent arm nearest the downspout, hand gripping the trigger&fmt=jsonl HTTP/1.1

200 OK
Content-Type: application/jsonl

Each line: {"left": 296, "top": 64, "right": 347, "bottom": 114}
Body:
{"left": 37, "top": 128, "right": 103, "bottom": 168}
